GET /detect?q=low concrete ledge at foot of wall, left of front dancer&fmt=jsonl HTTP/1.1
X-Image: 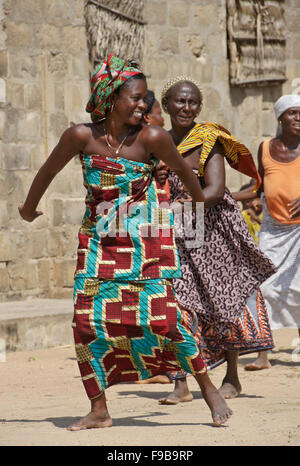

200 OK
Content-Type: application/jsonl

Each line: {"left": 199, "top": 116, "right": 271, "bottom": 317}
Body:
{"left": 0, "top": 299, "right": 73, "bottom": 351}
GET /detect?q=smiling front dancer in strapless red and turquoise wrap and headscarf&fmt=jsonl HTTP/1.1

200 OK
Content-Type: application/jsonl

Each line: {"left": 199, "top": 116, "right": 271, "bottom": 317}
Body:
{"left": 19, "top": 55, "right": 232, "bottom": 430}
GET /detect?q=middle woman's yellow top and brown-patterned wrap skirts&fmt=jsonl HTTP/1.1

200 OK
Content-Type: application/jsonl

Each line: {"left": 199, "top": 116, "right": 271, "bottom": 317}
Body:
{"left": 168, "top": 123, "right": 276, "bottom": 372}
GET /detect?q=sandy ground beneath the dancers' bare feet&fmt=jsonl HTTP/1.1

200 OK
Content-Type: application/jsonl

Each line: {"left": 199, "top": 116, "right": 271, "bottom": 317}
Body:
{"left": 0, "top": 330, "right": 300, "bottom": 446}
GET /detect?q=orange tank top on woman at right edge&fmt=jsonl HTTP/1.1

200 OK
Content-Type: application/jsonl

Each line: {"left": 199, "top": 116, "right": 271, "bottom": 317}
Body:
{"left": 262, "top": 139, "right": 300, "bottom": 224}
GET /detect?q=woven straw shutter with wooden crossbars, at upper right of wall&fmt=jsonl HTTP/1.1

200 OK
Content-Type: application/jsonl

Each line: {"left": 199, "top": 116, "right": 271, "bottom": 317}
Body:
{"left": 227, "top": 0, "right": 286, "bottom": 86}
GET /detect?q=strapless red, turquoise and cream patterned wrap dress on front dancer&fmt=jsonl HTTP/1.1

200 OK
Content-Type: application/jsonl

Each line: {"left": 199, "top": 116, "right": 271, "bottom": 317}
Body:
{"left": 73, "top": 154, "right": 206, "bottom": 399}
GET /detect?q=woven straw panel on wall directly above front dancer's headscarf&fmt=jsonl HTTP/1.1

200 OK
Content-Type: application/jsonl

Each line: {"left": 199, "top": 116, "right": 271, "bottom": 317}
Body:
{"left": 84, "top": 0, "right": 146, "bottom": 68}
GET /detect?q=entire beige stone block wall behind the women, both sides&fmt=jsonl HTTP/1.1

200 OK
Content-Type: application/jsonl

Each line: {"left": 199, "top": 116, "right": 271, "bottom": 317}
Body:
{"left": 0, "top": 0, "right": 300, "bottom": 301}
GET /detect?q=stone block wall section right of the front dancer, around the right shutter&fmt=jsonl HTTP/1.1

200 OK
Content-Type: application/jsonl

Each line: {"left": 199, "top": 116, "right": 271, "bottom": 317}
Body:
{"left": 144, "top": 0, "right": 300, "bottom": 190}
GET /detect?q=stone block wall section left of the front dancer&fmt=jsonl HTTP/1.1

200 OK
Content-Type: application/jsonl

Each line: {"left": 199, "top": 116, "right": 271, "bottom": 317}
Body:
{"left": 0, "top": 0, "right": 89, "bottom": 300}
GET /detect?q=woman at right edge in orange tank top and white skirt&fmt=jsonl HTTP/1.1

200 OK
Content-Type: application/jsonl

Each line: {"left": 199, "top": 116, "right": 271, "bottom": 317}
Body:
{"left": 245, "top": 94, "right": 300, "bottom": 370}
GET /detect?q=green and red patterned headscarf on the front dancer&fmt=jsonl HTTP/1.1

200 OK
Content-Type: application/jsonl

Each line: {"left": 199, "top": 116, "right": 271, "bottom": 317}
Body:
{"left": 86, "top": 54, "right": 142, "bottom": 122}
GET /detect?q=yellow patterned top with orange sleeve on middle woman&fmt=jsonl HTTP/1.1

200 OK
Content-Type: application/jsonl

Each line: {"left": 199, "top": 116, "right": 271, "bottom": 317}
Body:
{"left": 177, "top": 122, "right": 261, "bottom": 189}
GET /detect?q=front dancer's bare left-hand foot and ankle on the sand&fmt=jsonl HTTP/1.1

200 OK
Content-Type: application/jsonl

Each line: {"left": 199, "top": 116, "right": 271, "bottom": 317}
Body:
{"left": 68, "top": 392, "right": 112, "bottom": 431}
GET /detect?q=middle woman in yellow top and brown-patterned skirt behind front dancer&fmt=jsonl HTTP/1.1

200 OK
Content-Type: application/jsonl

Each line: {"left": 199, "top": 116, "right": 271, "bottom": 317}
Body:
{"left": 160, "top": 77, "right": 275, "bottom": 404}
